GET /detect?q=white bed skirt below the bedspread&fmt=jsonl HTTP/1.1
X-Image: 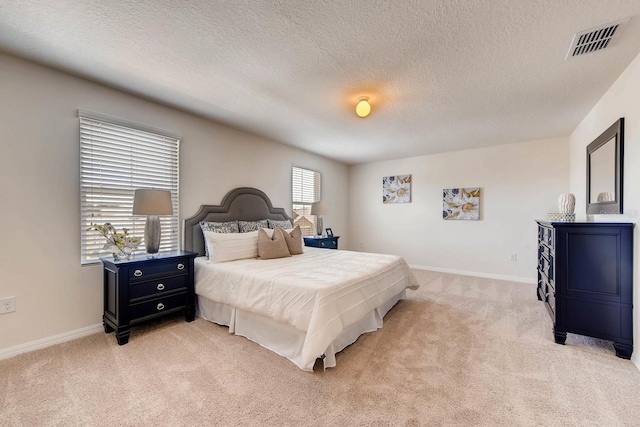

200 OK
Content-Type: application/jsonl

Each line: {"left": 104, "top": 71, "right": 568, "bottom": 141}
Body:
{"left": 196, "top": 290, "right": 406, "bottom": 371}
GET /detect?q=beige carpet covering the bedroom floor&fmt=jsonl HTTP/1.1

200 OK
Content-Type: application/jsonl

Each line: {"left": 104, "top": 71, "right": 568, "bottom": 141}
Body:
{"left": 0, "top": 271, "right": 640, "bottom": 426}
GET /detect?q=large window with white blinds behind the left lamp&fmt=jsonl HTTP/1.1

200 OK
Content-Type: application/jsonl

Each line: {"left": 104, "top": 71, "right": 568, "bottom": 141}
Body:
{"left": 78, "top": 110, "right": 180, "bottom": 264}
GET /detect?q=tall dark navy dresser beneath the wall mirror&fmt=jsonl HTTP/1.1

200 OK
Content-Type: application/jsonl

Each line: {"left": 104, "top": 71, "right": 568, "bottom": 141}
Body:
{"left": 536, "top": 221, "right": 634, "bottom": 359}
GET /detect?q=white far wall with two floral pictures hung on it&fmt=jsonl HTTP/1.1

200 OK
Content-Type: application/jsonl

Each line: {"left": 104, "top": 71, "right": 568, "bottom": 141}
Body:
{"left": 349, "top": 138, "right": 569, "bottom": 283}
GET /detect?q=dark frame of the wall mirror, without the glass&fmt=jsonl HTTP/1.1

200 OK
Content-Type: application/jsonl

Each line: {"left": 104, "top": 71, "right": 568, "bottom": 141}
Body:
{"left": 587, "top": 117, "right": 624, "bottom": 215}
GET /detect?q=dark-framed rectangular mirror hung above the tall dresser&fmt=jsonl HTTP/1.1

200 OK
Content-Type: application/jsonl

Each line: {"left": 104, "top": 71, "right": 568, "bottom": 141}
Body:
{"left": 587, "top": 118, "right": 624, "bottom": 214}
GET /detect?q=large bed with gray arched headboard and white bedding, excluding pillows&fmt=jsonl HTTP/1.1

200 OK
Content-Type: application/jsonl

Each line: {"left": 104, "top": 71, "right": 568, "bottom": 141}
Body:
{"left": 183, "top": 187, "right": 418, "bottom": 371}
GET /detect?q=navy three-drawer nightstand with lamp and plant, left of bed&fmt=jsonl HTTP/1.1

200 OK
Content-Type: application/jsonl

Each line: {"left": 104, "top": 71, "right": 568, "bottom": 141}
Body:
{"left": 101, "top": 251, "right": 198, "bottom": 345}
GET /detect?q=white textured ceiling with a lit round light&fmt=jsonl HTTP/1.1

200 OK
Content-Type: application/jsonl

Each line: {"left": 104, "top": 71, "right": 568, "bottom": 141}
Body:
{"left": 0, "top": 0, "right": 640, "bottom": 164}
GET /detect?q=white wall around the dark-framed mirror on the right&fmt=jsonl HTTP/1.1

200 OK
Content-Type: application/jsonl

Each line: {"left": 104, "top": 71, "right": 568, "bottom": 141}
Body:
{"left": 569, "top": 51, "right": 640, "bottom": 367}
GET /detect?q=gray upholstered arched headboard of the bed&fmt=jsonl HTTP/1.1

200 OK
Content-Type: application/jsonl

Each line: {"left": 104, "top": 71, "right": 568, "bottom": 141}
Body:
{"left": 183, "top": 187, "right": 292, "bottom": 255}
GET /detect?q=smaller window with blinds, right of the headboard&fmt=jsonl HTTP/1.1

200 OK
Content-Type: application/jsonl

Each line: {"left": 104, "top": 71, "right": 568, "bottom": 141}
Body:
{"left": 291, "top": 166, "right": 322, "bottom": 236}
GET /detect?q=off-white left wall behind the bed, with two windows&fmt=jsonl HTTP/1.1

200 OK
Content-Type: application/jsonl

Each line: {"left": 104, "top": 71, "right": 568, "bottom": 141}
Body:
{"left": 0, "top": 54, "right": 348, "bottom": 352}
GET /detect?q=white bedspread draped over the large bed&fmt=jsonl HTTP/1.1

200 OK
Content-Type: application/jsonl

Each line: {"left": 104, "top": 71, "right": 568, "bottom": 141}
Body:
{"left": 195, "top": 247, "right": 419, "bottom": 364}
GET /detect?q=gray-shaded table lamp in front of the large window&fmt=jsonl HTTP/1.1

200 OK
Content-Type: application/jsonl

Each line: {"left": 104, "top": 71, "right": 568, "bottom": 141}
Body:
{"left": 133, "top": 189, "right": 173, "bottom": 254}
